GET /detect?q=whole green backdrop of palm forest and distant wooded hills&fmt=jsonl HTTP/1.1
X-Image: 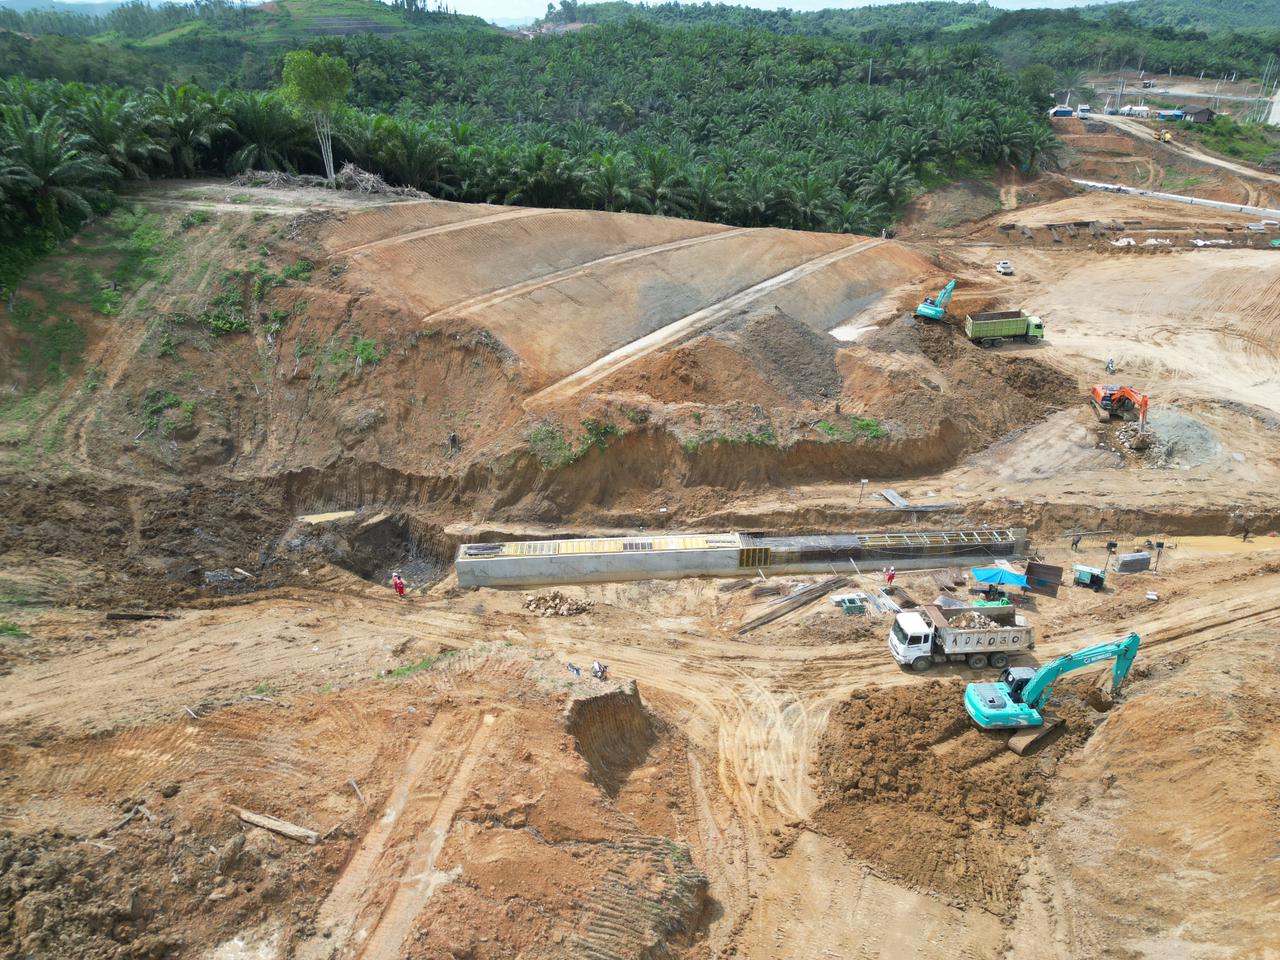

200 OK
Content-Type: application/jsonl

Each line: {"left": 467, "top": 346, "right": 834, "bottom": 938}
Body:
{"left": 0, "top": 0, "right": 1263, "bottom": 293}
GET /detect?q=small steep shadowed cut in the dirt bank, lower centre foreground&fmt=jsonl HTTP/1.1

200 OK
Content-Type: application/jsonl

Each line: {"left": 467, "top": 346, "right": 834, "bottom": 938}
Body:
{"left": 564, "top": 680, "right": 658, "bottom": 796}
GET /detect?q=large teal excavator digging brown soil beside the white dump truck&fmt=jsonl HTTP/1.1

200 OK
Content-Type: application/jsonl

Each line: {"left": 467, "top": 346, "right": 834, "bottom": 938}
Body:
{"left": 964, "top": 634, "right": 1142, "bottom": 753}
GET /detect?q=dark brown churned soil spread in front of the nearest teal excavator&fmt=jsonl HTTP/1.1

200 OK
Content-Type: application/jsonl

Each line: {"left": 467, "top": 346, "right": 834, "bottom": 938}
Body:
{"left": 812, "top": 682, "right": 1091, "bottom": 913}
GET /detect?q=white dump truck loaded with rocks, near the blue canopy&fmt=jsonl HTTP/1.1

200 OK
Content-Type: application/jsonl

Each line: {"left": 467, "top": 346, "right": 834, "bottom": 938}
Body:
{"left": 888, "top": 605, "right": 1036, "bottom": 672}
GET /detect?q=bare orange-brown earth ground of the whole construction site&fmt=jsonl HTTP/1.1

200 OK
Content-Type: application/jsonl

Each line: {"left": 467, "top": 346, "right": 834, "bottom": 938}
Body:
{"left": 0, "top": 110, "right": 1280, "bottom": 960}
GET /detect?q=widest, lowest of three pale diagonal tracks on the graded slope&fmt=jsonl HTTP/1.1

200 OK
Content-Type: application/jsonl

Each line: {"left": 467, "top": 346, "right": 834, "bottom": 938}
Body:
{"left": 525, "top": 238, "right": 887, "bottom": 410}
